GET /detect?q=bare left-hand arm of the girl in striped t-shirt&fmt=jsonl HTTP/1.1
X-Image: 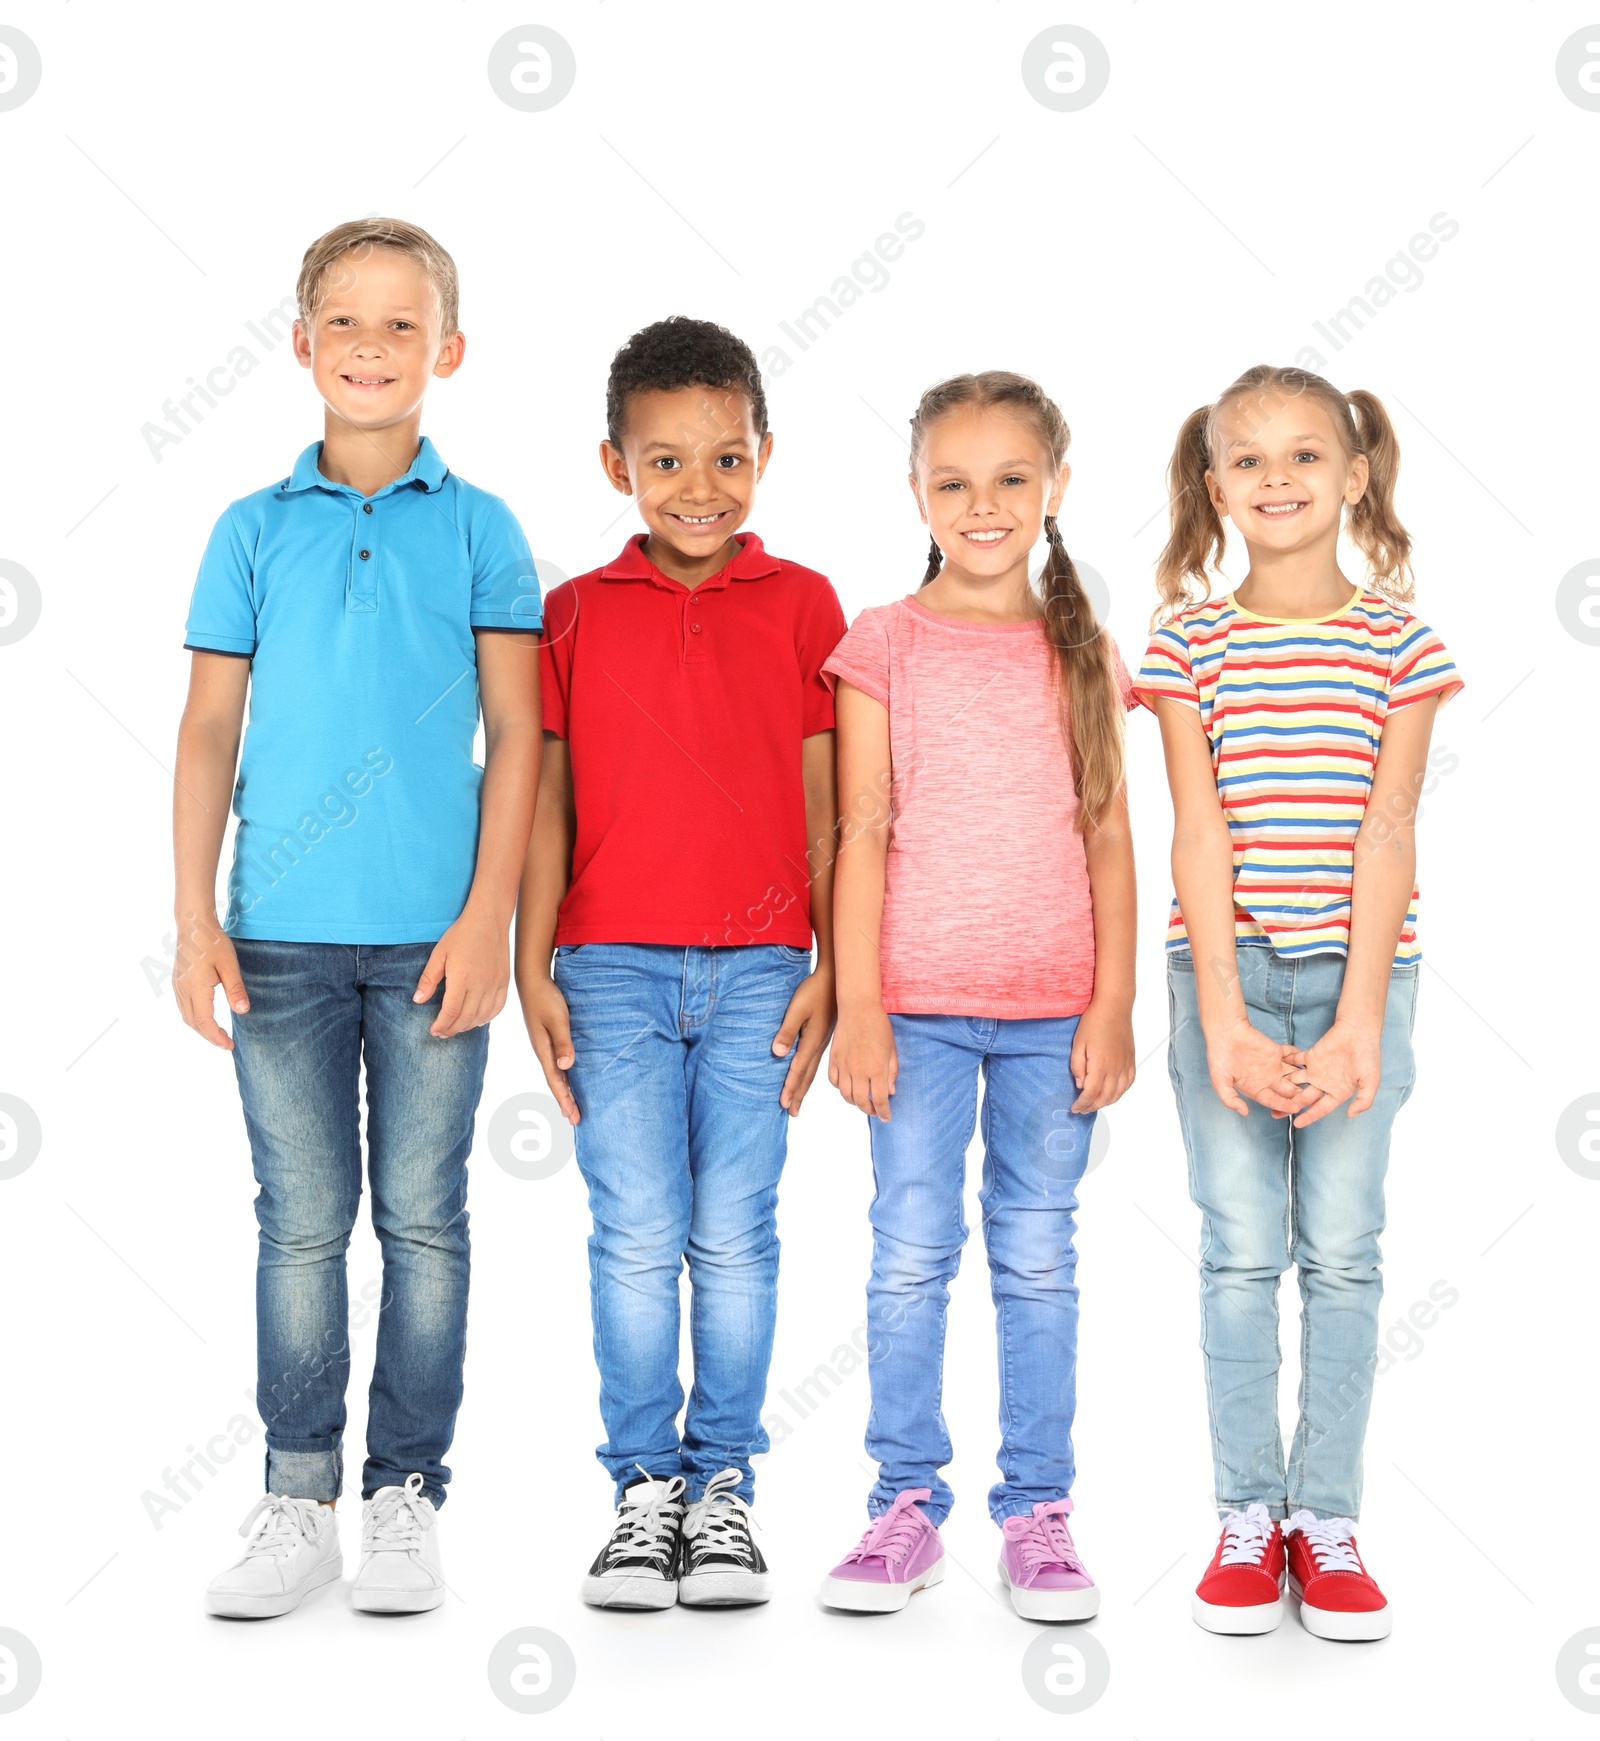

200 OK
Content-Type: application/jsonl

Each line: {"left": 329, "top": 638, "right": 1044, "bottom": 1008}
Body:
{"left": 1156, "top": 700, "right": 1308, "bottom": 1116}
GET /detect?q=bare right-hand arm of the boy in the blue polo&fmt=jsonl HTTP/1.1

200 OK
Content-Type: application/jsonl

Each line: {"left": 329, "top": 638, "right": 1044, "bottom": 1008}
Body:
{"left": 414, "top": 630, "right": 540, "bottom": 1039}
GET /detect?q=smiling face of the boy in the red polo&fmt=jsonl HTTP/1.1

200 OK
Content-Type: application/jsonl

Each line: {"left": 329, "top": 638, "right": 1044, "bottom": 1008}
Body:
{"left": 601, "top": 387, "right": 773, "bottom": 562}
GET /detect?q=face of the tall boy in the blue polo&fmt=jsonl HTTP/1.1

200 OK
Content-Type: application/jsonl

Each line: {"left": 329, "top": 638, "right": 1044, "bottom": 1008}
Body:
{"left": 294, "top": 247, "right": 467, "bottom": 430}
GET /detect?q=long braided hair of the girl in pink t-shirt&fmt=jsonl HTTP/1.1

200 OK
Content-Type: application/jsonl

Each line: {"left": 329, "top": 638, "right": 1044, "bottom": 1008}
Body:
{"left": 911, "top": 369, "right": 1123, "bottom": 832}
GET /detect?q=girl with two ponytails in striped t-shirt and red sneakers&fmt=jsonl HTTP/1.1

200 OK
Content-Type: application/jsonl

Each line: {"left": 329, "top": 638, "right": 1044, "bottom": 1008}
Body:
{"left": 1135, "top": 366, "right": 1461, "bottom": 1638}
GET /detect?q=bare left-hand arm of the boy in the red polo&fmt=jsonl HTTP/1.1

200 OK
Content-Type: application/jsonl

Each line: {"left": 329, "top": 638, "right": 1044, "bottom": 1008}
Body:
{"left": 517, "top": 731, "right": 578, "bottom": 1125}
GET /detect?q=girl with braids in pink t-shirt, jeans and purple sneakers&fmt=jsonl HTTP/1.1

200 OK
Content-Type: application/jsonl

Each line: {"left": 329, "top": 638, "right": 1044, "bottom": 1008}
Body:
{"left": 824, "top": 371, "right": 1133, "bottom": 1619}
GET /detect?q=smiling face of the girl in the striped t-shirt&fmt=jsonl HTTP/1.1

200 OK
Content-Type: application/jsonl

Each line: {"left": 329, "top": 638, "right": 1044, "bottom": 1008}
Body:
{"left": 1205, "top": 393, "right": 1367, "bottom": 555}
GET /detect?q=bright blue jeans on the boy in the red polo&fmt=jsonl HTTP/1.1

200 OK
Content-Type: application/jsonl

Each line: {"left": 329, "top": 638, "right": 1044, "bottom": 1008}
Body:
{"left": 555, "top": 944, "right": 811, "bottom": 1499}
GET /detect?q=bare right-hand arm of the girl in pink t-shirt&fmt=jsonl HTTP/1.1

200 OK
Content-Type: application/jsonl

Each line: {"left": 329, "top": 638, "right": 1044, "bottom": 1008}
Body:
{"left": 1072, "top": 787, "right": 1139, "bottom": 1112}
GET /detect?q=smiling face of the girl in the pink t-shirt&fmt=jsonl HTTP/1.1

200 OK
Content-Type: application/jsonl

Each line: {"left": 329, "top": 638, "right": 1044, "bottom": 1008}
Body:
{"left": 911, "top": 406, "right": 1071, "bottom": 578}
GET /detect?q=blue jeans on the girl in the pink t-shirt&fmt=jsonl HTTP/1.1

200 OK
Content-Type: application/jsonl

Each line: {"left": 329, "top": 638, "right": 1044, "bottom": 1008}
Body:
{"left": 867, "top": 1015, "right": 1095, "bottom": 1523}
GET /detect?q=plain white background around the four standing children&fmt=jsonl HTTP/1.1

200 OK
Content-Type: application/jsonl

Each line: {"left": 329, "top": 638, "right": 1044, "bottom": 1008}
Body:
{"left": 0, "top": 0, "right": 1600, "bottom": 1741}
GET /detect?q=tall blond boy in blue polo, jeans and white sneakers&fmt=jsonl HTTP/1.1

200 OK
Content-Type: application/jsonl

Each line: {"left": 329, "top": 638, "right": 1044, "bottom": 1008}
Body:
{"left": 174, "top": 219, "right": 541, "bottom": 1617}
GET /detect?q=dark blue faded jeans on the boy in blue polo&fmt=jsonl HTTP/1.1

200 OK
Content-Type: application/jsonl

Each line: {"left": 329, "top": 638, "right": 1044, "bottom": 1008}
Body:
{"left": 233, "top": 938, "right": 489, "bottom": 1506}
